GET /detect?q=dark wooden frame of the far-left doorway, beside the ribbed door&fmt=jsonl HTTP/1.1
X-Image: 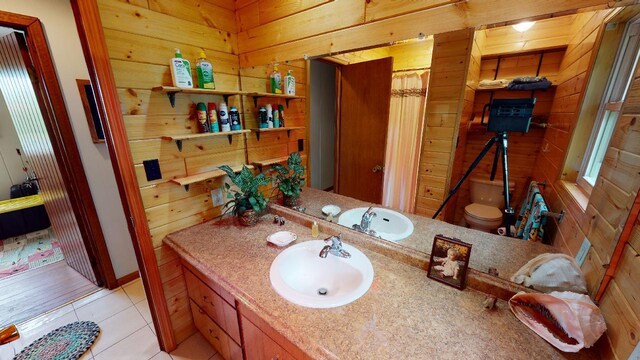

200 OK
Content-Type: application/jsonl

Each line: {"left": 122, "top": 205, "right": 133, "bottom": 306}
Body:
{"left": 0, "top": 11, "right": 118, "bottom": 289}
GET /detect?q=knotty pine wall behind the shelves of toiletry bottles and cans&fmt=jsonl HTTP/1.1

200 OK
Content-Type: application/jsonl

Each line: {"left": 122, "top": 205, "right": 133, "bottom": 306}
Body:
{"left": 98, "top": 0, "right": 308, "bottom": 342}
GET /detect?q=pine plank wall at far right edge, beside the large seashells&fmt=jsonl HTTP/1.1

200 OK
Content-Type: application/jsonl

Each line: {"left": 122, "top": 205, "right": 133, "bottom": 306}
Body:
{"left": 596, "top": 60, "right": 640, "bottom": 359}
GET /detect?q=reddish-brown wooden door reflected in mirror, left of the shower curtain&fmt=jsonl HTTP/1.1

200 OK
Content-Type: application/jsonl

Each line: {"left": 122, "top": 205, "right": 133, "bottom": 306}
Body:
{"left": 336, "top": 57, "right": 393, "bottom": 204}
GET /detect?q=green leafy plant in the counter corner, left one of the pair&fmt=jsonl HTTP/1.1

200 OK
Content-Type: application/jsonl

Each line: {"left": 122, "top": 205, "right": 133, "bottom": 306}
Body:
{"left": 219, "top": 165, "right": 271, "bottom": 216}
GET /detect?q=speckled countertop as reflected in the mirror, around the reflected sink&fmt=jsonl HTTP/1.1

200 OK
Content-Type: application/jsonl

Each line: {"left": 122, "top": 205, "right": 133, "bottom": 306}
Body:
{"left": 300, "top": 188, "right": 559, "bottom": 279}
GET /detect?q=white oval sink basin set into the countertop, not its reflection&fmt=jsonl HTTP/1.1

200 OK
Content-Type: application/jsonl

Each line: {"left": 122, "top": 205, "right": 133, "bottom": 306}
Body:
{"left": 270, "top": 240, "right": 373, "bottom": 309}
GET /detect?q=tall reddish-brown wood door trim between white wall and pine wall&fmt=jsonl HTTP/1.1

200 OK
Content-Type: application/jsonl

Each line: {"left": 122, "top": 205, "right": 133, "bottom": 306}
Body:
{"left": 71, "top": 0, "right": 176, "bottom": 352}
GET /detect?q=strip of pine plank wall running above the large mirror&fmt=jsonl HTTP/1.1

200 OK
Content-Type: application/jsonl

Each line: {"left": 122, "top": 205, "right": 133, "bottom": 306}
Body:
{"left": 237, "top": 0, "right": 608, "bottom": 67}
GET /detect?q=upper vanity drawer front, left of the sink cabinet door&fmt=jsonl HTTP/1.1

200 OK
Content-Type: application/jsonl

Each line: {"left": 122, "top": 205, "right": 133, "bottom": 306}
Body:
{"left": 184, "top": 269, "right": 241, "bottom": 344}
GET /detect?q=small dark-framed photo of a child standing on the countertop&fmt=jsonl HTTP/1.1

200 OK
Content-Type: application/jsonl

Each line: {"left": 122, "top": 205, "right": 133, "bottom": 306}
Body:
{"left": 427, "top": 235, "right": 471, "bottom": 290}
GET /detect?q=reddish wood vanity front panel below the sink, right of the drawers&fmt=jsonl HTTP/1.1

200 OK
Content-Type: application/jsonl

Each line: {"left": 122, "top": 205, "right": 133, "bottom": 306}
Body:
{"left": 242, "top": 316, "right": 295, "bottom": 360}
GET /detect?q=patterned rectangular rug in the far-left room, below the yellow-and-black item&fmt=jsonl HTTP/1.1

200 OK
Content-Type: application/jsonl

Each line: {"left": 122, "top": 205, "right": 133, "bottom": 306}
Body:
{"left": 0, "top": 229, "right": 64, "bottom": 279}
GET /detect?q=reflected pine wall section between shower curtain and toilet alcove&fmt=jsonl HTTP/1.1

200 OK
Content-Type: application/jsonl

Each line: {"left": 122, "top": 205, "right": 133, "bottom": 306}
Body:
{"left": 416, "top": 29, "right": 474, "bottom": 216}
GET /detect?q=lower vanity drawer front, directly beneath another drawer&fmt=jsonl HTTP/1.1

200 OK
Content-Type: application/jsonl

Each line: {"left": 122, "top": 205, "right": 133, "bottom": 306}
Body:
{"left": 191, "top": 300, "right": 242, "bottom": 360}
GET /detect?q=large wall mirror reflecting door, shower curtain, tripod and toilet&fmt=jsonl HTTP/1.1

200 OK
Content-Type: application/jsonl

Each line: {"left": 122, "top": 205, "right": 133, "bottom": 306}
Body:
{"left": 268, "top": 8, "right": 638, "bottom": 292}
